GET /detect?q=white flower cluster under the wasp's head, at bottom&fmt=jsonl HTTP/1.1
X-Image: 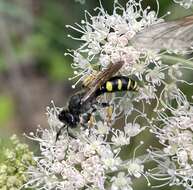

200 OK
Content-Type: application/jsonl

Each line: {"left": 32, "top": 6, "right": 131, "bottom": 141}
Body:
{"left": 25, "top": 108, "right": 144, "bottom": 190}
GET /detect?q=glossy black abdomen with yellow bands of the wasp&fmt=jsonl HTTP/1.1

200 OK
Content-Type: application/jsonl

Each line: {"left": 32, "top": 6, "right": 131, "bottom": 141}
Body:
{"left": 96, "top": 76, "right": 138, "bottom": 96}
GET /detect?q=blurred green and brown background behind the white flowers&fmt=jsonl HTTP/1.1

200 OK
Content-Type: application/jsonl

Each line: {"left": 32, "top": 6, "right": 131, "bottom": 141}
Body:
{"left": 0, "top": 0, "right": 192, "bottom": 189}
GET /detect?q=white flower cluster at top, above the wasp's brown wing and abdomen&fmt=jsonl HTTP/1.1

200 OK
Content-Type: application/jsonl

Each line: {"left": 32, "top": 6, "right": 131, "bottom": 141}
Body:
{"left": 67, "top": 0, "right": 163, "bottom": 83}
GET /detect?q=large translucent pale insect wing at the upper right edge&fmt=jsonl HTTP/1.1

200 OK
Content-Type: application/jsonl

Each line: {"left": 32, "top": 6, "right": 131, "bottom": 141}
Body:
{"left": 131, "top": 15, "right": 193, "bottom": 50}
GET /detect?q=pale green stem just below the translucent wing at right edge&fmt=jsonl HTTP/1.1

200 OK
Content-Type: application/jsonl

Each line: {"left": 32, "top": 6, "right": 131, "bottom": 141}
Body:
{"left": 162, "top": 55, "right": 193, "bottom": 67}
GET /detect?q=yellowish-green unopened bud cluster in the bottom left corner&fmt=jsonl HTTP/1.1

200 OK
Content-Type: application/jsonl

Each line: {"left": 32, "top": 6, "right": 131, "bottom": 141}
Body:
{"left": 0, "top": 135, "right": 35, "bottom": 190}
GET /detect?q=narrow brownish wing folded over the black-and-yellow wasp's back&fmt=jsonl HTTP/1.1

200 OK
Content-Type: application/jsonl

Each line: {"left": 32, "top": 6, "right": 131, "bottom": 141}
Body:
{"left": 81, "top": 61, "right": 124, "bottom": 103}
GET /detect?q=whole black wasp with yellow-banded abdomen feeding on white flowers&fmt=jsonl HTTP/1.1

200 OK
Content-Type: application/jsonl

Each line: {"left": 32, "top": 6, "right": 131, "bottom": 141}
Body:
{"left": 56, "top": 62, "right": 138, "bottom": 139}
